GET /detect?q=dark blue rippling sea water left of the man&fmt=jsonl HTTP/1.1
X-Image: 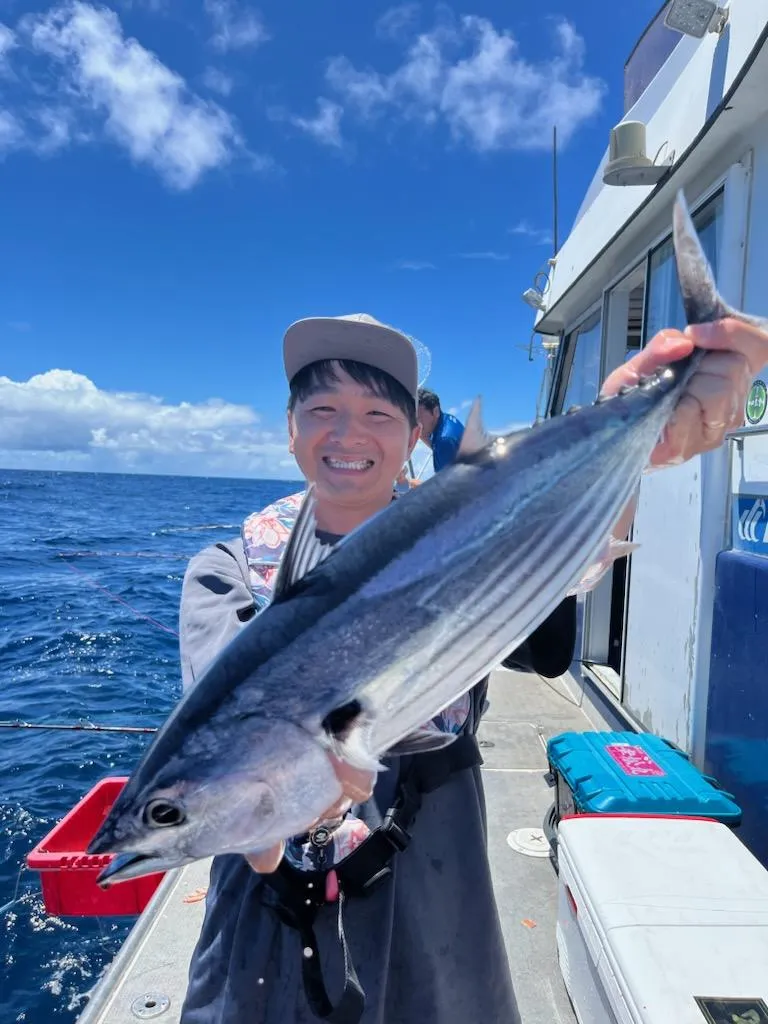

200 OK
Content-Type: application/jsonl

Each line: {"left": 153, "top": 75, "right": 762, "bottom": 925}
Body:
{"left": 0, "top": 469, "right": 297, "bottom": 1024}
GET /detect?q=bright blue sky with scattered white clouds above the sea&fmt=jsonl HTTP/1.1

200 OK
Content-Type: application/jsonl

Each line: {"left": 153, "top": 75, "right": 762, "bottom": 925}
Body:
{"left": 0, "top": 0, "right": 658, "bottom": 476}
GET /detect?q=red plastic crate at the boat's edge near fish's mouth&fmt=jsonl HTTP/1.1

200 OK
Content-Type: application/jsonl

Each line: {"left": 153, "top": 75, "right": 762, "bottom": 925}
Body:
{"left": 27, "top": 776, "right": 165, "bottom": 918}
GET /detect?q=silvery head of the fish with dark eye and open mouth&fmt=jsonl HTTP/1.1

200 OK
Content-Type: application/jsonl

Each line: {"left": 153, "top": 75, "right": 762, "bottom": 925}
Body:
{"left": 88, "top": 719, "right": 341, "bottom": 884}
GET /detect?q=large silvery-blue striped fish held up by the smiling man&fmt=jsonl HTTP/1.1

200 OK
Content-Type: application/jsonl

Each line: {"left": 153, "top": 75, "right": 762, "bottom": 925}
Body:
{"left": 88, "top": 193, "right": 766, "bottom": 885}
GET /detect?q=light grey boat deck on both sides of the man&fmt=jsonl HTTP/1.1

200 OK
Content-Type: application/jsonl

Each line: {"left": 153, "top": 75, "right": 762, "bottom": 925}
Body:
{"left": 78, "top": 670, "right": 604, "bottom": 1024}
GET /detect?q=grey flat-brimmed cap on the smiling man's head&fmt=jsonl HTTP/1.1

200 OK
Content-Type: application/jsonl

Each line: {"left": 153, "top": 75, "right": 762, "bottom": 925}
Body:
{"left": 283, "top": 313, "right": 419, "bottom": 399}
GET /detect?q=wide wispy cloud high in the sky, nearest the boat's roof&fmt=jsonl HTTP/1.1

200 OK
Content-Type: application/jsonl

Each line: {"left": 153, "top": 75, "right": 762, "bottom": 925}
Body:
{"left": 327, "top": 15, "right": 605, "bottom": 153}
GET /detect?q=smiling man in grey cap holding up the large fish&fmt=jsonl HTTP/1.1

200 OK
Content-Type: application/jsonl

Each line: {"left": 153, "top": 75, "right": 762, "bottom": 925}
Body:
{"left": 180, "top": 314, "right": 768, "bottom": 1024}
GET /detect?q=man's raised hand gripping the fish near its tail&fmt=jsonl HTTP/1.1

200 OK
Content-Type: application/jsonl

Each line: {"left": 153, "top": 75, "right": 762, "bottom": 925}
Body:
{"left": 601, "top": 319, "right": 768, "bottom": 468}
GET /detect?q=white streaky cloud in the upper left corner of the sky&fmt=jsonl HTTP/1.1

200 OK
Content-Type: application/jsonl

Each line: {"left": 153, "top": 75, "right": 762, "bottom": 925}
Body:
{"left": 0, "top": 0, "right": 272, "bottom": 189}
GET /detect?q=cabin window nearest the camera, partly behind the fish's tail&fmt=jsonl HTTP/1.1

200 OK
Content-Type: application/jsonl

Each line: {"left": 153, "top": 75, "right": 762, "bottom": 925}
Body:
{"left": 643, "top": 190, "right": 723, "bottom": 344}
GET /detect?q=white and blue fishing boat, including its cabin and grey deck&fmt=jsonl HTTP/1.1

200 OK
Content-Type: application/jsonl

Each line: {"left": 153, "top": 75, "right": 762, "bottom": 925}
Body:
{"left": 33, "top": 0, "right": 768, "bottom": 1024}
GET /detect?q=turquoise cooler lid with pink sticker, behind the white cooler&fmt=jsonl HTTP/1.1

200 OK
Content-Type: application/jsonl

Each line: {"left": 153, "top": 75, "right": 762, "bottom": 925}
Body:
{"left": 547, "top": 732, "right": 741, "bottom": 827}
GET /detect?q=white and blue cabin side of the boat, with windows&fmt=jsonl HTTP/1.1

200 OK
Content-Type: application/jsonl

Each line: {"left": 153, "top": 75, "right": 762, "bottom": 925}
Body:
{"left": 536, "top": 0, "right": 768, "bottom": 865}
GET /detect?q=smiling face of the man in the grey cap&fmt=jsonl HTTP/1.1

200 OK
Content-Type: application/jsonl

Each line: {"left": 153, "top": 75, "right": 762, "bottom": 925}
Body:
{"left": 288, "top": 370, "right": 419, "bottom": 506}
